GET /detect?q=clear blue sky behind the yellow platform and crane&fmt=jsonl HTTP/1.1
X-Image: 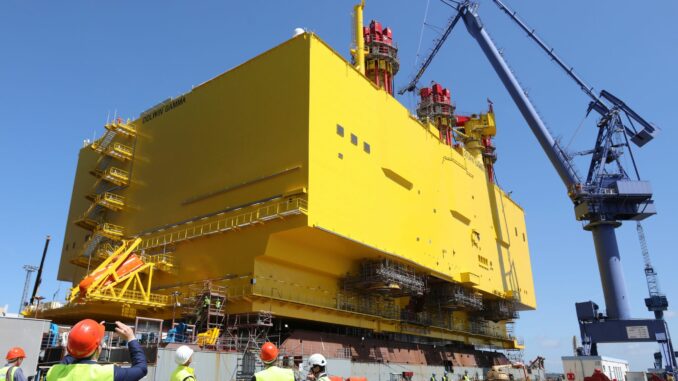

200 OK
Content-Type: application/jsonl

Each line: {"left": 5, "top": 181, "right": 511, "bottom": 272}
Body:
{"left": 0, "top": 0, "right": 678, "bottom": 370}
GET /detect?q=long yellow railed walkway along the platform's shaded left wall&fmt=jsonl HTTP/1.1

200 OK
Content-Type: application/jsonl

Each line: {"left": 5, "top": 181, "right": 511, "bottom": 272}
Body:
{"left": 139, "top": 198, "right": 307, "bottom": 249}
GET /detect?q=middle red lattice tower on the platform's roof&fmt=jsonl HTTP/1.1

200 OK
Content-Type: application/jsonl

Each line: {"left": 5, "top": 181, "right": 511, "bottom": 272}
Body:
{"left": 417, "top": 83, "right": 457, "bottom": 145}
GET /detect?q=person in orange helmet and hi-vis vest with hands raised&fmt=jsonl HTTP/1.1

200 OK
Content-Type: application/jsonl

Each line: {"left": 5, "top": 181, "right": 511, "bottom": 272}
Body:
{"left": 47, "top": 319, "right": 148, "bottom": 381}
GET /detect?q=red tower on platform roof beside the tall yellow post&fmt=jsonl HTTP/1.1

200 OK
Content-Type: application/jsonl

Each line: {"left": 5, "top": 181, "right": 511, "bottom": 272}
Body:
{"left": 363, "top": 20, "right": 400, "bottom": 95}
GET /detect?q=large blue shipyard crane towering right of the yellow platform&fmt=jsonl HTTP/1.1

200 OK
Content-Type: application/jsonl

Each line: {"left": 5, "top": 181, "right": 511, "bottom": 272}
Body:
{"left": 401, "top": 0, "right": 677, "bottom": 374}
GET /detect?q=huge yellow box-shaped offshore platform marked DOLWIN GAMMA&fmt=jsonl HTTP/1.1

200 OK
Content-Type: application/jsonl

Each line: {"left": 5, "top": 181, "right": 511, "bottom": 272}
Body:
{"left": 42, "top": 5, "right": 536, "bottom": 349}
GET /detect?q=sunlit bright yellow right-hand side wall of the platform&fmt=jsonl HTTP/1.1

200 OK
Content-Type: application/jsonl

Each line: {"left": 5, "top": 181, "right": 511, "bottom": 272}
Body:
{"left": 309, "top": 34, "right": 536, "bottom": 308}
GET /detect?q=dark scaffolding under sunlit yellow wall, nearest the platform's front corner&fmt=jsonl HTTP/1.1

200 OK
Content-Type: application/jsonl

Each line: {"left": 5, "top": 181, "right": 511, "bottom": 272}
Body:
{"left": 342, "top": 259, "right": 426, "bottom": 297}
